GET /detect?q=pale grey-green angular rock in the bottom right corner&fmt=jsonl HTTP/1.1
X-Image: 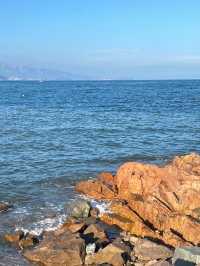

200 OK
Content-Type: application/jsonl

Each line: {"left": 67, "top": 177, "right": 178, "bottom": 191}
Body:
{"left": 172, "top": 247, "right": 200, "bottom": 265}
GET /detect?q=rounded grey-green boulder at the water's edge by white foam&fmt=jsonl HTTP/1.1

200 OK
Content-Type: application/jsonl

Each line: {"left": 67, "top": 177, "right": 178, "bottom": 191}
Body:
{"left": 71, "top": 200, "right": 91, "bottom": 218}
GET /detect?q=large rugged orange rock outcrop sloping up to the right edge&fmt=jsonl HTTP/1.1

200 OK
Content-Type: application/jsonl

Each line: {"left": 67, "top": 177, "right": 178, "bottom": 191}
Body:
{"left": 76, "top": 153, "right": 200, "bottom": 247}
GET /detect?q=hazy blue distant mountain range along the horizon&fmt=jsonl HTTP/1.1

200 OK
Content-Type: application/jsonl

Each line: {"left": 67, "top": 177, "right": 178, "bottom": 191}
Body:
{"left": 0, "top": 64, "right": 85, "bottom": 80}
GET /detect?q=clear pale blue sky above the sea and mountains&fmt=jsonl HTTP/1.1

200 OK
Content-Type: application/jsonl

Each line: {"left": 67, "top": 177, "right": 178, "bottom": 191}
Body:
{"left": 0, "top": 0, "right": 200, "bottom": 79}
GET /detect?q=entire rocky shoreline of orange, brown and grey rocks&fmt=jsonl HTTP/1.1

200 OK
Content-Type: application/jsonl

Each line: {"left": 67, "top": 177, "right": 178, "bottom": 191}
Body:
{"left": 0, "top": 153, "right": 200, "bottom": 266}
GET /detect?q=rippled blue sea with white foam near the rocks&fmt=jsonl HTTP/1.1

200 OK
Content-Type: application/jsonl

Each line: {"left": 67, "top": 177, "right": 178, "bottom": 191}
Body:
{"left": 0, "top": 80, "right": 200, "bottom": 266}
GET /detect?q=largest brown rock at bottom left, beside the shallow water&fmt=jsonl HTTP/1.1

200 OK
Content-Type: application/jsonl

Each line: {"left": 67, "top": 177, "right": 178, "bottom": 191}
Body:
{"left": 23, "top": 232, "right": 85, "bottom": 266}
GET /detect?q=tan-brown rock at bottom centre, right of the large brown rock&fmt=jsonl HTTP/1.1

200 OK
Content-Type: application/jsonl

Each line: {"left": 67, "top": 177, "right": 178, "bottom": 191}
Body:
{"left": 85, "top": 244, "right": 125, "bottom": 266}
